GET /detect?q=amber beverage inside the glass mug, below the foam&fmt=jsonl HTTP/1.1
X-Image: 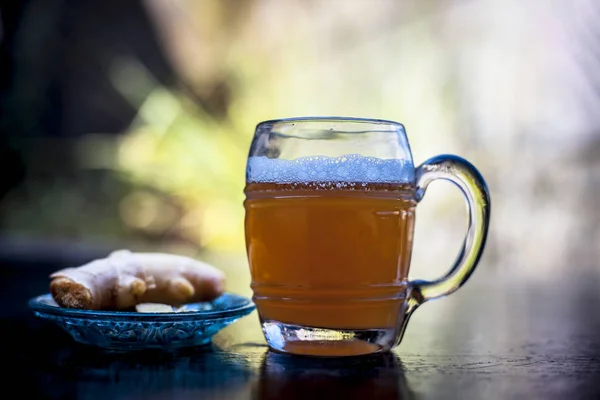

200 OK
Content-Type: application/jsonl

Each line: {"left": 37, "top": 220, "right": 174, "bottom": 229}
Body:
{"left": 245, "top": 182, "right": 416, "bottom": 330}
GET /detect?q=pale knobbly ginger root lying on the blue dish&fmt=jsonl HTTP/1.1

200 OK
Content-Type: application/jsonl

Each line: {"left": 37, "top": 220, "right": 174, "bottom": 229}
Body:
{"left": 50, "top": 250, "right": 225, "bottom": 310}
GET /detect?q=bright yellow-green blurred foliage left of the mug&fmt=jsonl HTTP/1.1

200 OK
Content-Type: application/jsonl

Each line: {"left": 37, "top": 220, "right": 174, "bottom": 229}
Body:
{"left": 114, "top": 59, "right": 250, "bottom": 250}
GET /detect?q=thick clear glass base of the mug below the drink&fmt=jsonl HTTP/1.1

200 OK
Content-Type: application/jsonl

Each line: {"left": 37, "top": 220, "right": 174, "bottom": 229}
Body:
{"left": 262, "top": 321, "right": 397, "bottom": 357}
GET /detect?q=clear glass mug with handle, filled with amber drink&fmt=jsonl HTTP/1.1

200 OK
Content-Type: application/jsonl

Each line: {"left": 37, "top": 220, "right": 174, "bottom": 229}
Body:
{"left": 244, "top": 117, "right": 490, "bottom": 356}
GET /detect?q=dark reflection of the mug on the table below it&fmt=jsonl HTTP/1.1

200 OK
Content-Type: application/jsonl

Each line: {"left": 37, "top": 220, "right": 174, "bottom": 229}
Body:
{"left": 252, "top": 352, "right": 416, "bottom": 400}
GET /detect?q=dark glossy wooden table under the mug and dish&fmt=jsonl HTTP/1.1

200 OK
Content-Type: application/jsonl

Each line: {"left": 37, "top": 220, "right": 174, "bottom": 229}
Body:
{"left": 0, "top": 248, "right": 600, "bottom": 399}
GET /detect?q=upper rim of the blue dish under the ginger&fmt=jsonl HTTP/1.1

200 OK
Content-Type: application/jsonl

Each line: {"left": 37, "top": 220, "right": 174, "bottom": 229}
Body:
{"left": 28, "top": 292, "right": 256, "bottom": 322}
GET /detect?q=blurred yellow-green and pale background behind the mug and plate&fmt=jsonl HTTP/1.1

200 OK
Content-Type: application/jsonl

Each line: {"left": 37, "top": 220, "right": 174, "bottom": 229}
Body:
{"left": 0, "top": 0, "right": 600, "bottom": 287}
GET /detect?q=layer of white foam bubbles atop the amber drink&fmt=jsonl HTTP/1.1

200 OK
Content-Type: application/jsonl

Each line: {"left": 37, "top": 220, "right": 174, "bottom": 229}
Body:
{"left": 246, "top": 154, "right": 415, "bottom": 183}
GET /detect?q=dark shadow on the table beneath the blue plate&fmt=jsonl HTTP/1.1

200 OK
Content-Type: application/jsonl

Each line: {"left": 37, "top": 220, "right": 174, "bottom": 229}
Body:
{"left": 7, "top": 321, "right": 256, "bottom": 399}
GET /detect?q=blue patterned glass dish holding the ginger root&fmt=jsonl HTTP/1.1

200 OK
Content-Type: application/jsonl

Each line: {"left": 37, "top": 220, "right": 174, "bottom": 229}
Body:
{"left": 29, "top": 293, "right": 255, "bottom": 351}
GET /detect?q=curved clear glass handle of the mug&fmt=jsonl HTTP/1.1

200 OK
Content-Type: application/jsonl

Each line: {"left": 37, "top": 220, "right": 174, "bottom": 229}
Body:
{"left": 396, "top": 154, "right": 491, "bottom": 344}
